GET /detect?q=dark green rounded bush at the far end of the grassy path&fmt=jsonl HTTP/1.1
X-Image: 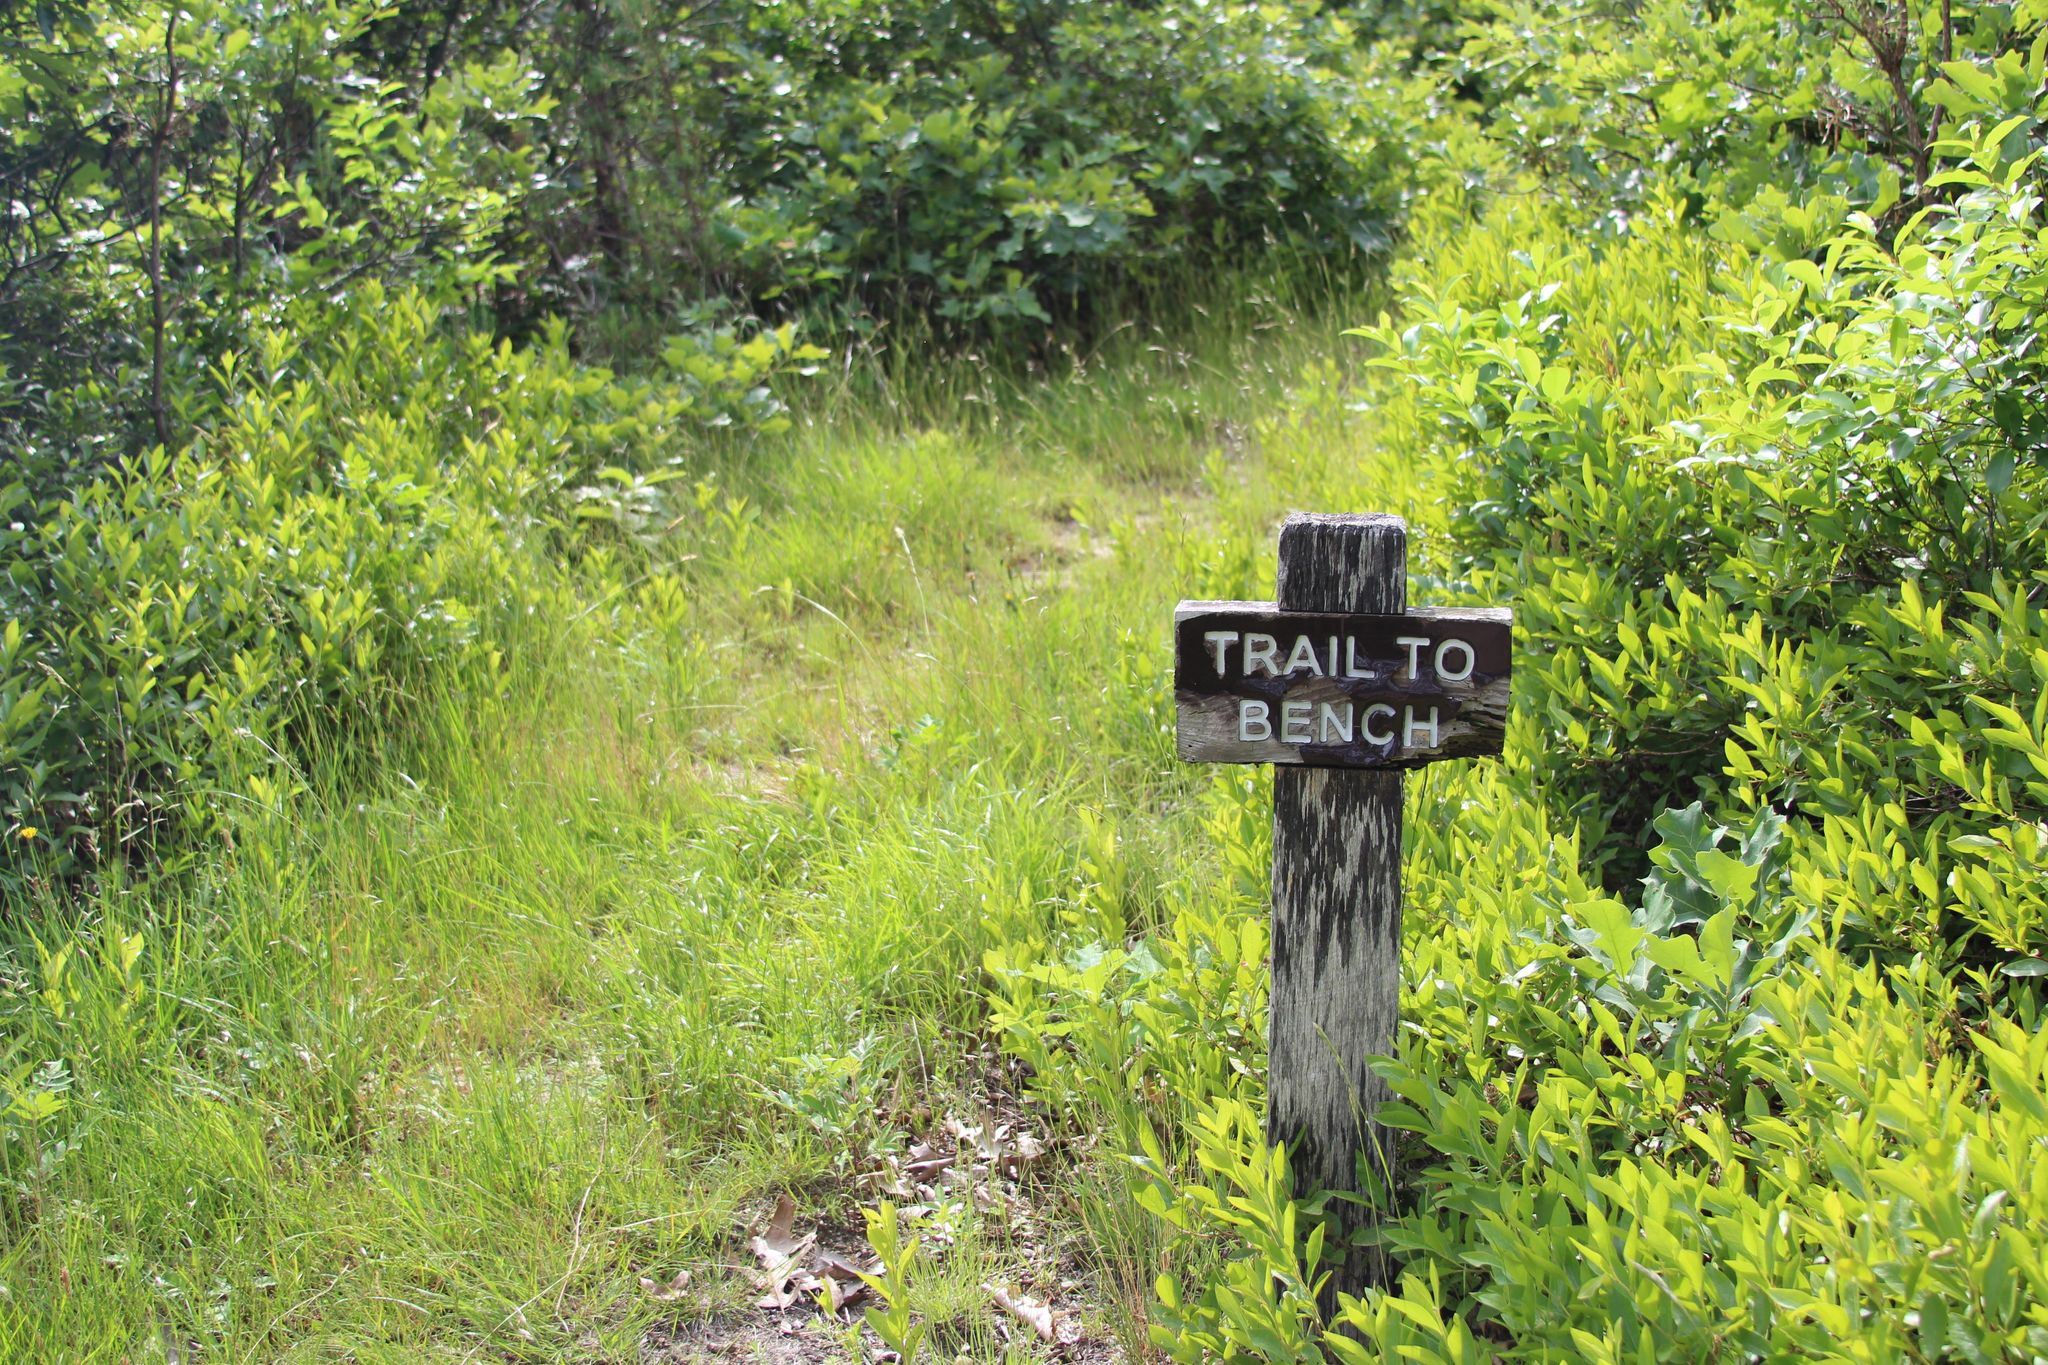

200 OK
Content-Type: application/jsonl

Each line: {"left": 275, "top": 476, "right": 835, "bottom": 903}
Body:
{"left": 541, "top": 0, "right": 1409, "bottom": 331}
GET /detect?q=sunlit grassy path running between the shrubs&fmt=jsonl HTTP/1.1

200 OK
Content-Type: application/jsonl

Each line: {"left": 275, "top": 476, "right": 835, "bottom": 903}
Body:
{"left": 0, "top": 263, "right": 1384, "bottom": 1361}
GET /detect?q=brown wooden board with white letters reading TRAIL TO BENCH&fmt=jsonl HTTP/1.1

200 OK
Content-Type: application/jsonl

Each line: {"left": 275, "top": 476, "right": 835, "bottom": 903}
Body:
{"left": 1174, "top": 602, "right": 1513, "bottom": 767}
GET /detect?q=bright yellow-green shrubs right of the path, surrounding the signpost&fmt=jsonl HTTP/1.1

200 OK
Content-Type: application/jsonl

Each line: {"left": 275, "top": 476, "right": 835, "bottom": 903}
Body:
{"left": 989, "top": 4, "right": 2048, "bottom": 1361}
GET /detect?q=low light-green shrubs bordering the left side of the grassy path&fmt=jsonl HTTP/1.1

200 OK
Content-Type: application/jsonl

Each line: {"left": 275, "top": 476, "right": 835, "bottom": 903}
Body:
{"left": 0, "top": 284, "right": 809, "bottom": 888}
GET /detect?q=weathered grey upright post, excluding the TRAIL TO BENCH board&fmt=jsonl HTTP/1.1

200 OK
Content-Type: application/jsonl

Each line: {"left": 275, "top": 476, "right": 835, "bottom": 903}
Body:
{"left": 1266, "top": 514, "right": 1407, "bottom": 1302}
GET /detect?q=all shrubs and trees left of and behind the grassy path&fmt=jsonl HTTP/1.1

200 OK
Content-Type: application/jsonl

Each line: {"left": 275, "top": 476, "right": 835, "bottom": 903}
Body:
{"left": 0, "top": 0, "right": 1407, "bottom": 870}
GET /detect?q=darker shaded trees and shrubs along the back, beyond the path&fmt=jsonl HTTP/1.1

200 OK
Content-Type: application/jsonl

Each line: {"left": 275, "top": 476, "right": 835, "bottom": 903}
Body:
{"left": 0, "top": 0, "right": 1411, "bottom": 465}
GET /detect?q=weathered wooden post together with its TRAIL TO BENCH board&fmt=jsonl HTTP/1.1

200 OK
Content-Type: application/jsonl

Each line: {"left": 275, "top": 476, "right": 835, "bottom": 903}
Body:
{"left": 1174, "top": 514, "right": 1513, "bottom": 1300}
